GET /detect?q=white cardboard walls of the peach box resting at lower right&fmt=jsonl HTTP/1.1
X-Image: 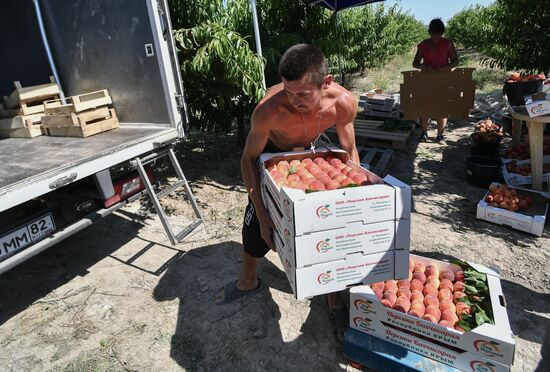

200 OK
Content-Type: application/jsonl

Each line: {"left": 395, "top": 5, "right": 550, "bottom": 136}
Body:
{"left": 350, "top": 255, "right": 515, "bottom": 371}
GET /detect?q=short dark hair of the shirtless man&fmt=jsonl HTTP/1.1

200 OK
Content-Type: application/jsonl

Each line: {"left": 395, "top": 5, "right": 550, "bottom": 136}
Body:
{"left": 279, "top": 44, "right": 328, "bottom": 86}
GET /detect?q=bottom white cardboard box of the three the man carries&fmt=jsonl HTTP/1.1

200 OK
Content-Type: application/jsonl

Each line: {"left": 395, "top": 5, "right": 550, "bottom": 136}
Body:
{"left": 273, "top": 231, "right": 409, "bottom": 300}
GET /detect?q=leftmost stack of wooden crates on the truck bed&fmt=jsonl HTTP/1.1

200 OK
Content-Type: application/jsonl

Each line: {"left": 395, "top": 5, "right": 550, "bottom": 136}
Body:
{"left": 0, "top": 77, "right": 59, "bottom": 138}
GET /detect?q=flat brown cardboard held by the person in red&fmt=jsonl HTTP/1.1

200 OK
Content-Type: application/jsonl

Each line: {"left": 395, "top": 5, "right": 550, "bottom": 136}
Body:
{"left": 400, "top": 68, "right": 475, "bottom": 120}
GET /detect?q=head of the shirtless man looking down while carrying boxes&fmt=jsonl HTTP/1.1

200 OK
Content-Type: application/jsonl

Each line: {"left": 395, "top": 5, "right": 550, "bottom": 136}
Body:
{"left": 279, "top": 44, "right": 332, "bottom": 113}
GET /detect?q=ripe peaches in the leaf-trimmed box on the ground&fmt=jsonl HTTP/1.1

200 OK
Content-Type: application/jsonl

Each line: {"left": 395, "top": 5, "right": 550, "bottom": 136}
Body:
{"left": 370, "top": 260, "right": 472, "bottom": 332}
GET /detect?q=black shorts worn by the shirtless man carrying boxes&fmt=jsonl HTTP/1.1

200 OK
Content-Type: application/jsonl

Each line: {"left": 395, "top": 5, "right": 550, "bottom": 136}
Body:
{"left": 242, "top": 141, "right": 282, "bottom": 258}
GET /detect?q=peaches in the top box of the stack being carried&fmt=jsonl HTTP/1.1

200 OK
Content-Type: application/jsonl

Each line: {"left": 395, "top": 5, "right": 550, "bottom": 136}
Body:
{"left": 267, "top": 155, "right": 371, "bottom": 191}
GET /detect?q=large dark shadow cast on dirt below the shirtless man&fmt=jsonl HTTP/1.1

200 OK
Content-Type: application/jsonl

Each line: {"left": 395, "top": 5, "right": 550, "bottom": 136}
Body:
{"left": 154, "top": 242, "right": 350, "bottom": 371}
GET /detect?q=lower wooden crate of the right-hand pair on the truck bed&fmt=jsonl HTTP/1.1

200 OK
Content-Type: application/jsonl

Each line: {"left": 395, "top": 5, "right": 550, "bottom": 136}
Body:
{"left": 44, "top": 107, "right": 119, "bottom": 138}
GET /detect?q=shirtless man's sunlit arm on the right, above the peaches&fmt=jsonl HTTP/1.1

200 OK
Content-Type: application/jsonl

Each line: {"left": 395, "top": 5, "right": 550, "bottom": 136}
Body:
{"left": 336, "top": 92, "right": 360, "bottom": 164}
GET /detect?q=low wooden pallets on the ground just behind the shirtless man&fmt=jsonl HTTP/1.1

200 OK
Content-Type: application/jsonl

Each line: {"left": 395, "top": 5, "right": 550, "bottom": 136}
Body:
{"left": 326, "top": 119, "right": 414, "bottom": 150}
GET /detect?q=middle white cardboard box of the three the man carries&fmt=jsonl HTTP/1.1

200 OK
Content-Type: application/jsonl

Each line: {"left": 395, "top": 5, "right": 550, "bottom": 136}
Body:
{"left": 264, "top": 183, "right": 411, "bottom": 268}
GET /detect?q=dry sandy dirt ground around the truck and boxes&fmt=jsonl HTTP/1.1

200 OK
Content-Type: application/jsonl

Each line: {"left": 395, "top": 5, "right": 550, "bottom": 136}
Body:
{"left": 0, "top": 98, "right": 550, "bottom": 371}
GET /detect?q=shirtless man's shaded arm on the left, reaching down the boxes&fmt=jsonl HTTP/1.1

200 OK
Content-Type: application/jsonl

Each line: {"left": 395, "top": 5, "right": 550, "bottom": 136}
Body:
{"left": 241, "top": 103, "right": 273, "bottom": 249}
